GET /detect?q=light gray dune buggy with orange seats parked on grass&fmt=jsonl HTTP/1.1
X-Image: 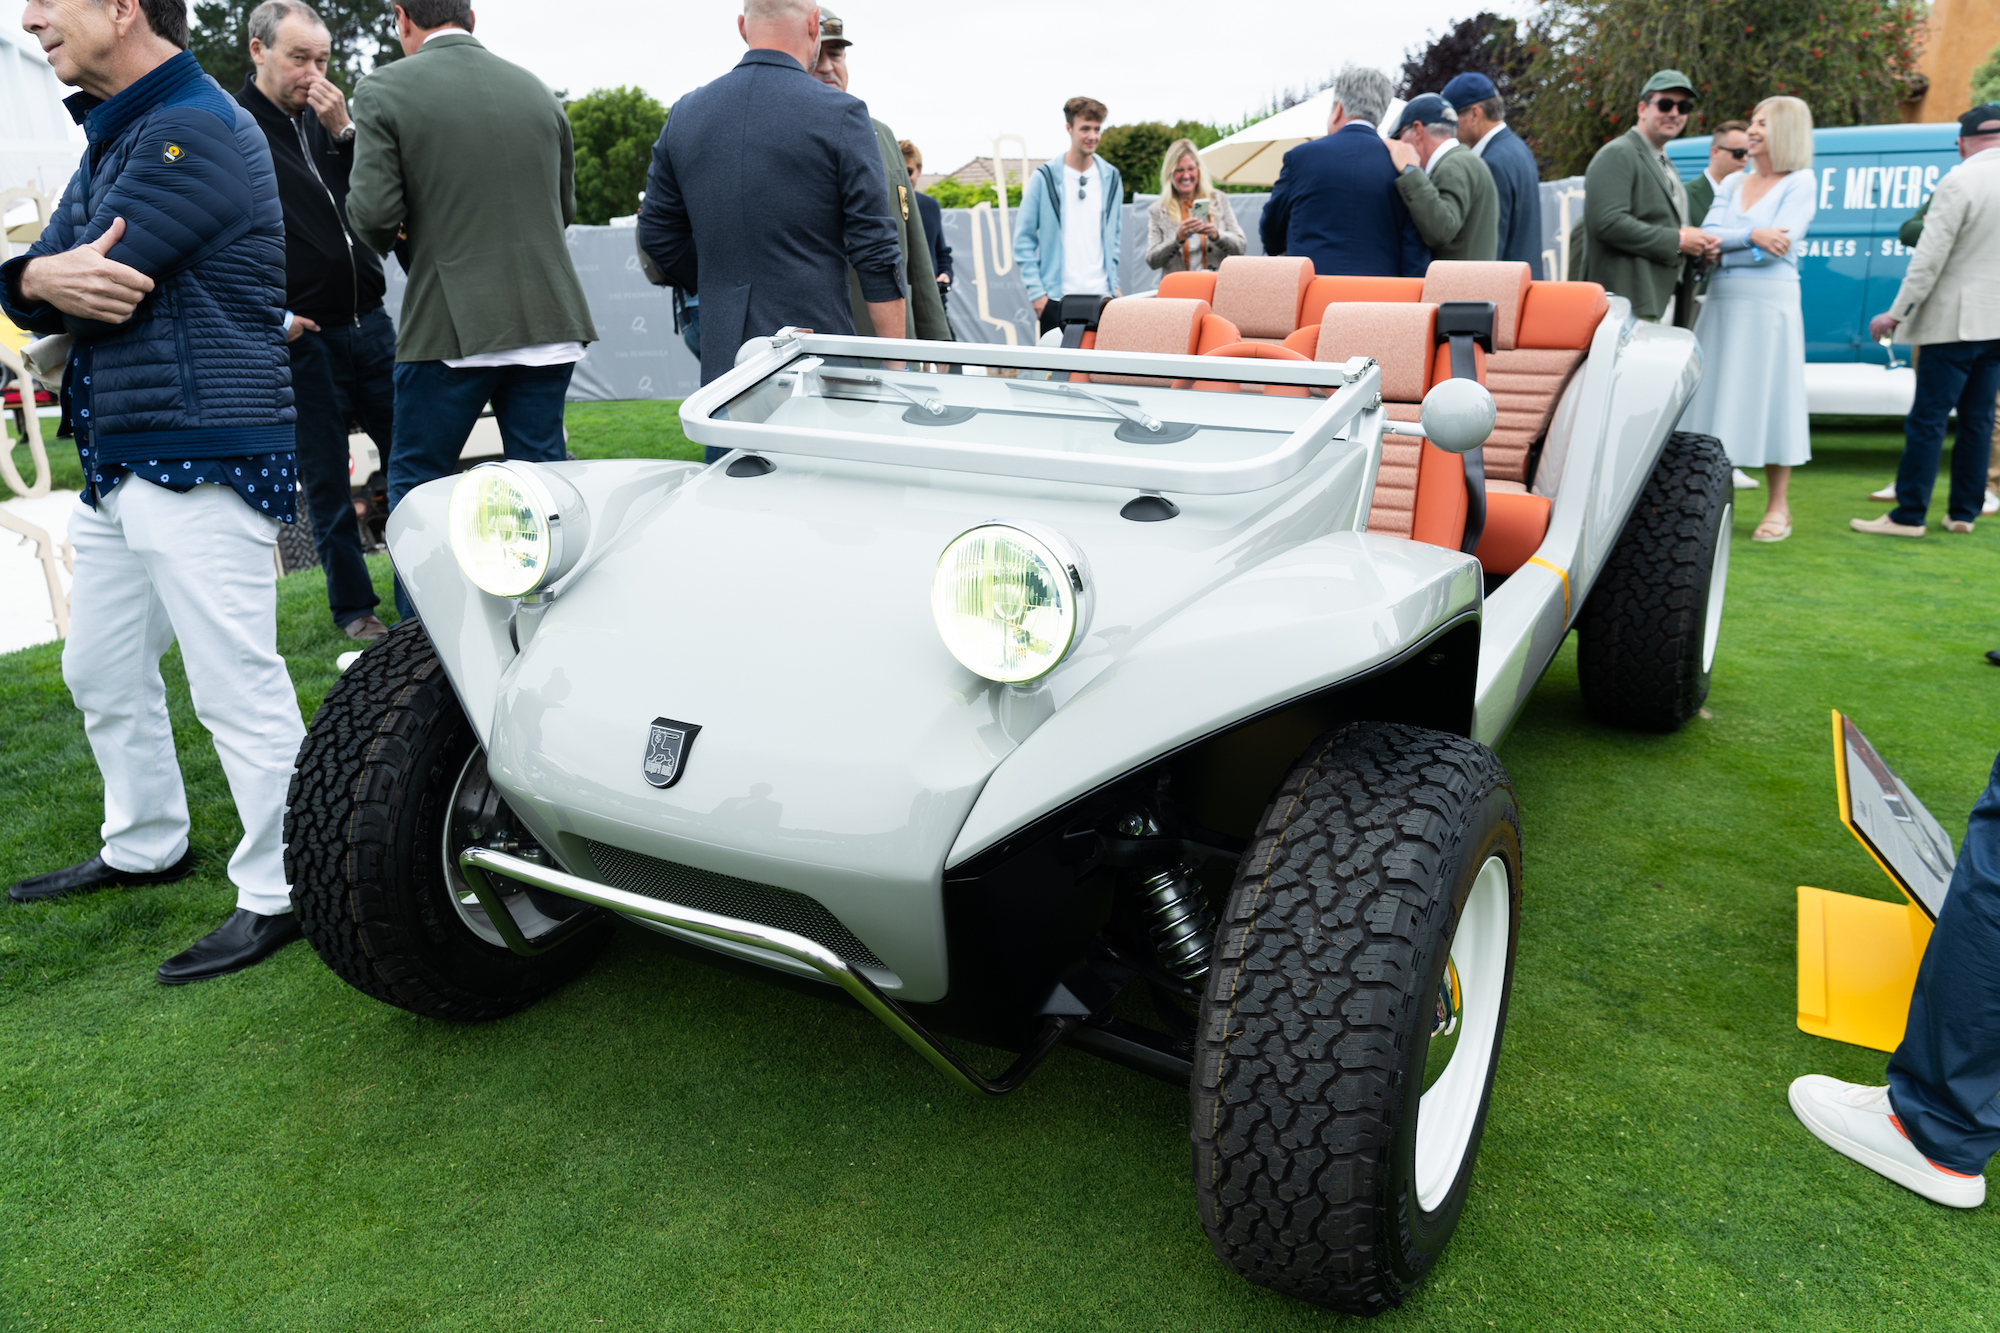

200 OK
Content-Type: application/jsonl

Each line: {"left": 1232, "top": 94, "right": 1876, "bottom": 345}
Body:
{"left": 286, "top": 260, "right": 1732, "bottom": 1313}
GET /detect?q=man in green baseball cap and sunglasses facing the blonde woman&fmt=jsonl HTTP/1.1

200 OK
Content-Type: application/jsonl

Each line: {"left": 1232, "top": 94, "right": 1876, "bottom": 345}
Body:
{"left": 1570, "top": 70, "right": 1718, "bottom": 322}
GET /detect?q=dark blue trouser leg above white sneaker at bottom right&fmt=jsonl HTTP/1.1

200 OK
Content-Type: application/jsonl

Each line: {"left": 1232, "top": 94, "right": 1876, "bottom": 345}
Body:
{"left": 1888, "top": 752, "right": 2000, "bottom": 1175}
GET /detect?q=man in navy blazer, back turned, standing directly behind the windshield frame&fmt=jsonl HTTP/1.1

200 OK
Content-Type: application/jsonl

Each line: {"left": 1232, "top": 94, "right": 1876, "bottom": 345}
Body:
{"left": 638, "top": 0, "right": 904, "bottom": 384}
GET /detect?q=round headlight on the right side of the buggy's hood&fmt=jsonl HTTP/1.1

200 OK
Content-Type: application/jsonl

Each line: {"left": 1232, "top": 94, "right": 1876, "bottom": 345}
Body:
{"left": 930, "top": 522, "right": 1088, "bottom": 685}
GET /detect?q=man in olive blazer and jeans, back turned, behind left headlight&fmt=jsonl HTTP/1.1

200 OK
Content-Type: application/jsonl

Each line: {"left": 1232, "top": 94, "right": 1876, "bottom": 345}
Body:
{"left": 348, "top": 0, "right": 598, "bottom": 616}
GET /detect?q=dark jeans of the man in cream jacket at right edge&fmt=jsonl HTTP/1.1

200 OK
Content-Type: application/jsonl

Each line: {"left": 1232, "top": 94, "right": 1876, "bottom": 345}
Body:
{"left": 1888, "top": 338, "right": 2000, "bottom": 528}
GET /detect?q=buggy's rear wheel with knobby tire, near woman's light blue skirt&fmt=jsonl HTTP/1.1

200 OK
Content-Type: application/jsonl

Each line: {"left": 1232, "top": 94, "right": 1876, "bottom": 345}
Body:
{"left": 1576, "top": 430, "right": 1734, "bottom": 731}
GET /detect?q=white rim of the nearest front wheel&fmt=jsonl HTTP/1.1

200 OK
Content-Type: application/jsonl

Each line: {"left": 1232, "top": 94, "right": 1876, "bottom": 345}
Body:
{"left": 1416, "top": 857, "right": 1512, "bottom": 1213}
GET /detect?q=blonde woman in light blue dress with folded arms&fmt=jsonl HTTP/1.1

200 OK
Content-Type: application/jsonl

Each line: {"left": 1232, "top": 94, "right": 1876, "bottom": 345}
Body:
{"left": 1680, "top": 98, "right": 1818, "bottom": 542}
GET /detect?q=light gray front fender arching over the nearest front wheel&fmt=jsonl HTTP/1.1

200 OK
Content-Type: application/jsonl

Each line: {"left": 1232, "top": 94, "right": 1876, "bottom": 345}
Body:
{"left": 946, "top": 532, "right": 1482, "bottom": 867}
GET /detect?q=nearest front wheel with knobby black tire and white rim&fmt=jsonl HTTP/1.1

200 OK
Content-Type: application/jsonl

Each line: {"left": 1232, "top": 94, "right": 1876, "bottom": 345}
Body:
{"left": 1192, "top": 723, "right": 1520, "bottom": 1315}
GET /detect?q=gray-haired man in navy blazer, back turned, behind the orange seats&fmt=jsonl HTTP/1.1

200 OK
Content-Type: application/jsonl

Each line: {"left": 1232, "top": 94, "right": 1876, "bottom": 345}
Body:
{"left": 1258, "top": 68, "right": 1430, "bottom": 278}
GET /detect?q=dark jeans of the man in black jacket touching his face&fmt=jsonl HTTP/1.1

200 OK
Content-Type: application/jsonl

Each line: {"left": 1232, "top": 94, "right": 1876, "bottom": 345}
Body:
{"left": 292, "top": 306, "right": 396, "bottom": 626}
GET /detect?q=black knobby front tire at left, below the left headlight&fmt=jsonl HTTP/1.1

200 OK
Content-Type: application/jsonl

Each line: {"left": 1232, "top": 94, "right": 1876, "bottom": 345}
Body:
{"left": 284, "top": 620, "right": 610, "bottom": 1021}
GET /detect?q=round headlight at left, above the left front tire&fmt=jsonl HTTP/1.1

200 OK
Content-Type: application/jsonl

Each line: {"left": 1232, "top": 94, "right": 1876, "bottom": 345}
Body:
{"left": 450, "top": 462, "right": 590, "bottom": 596}
